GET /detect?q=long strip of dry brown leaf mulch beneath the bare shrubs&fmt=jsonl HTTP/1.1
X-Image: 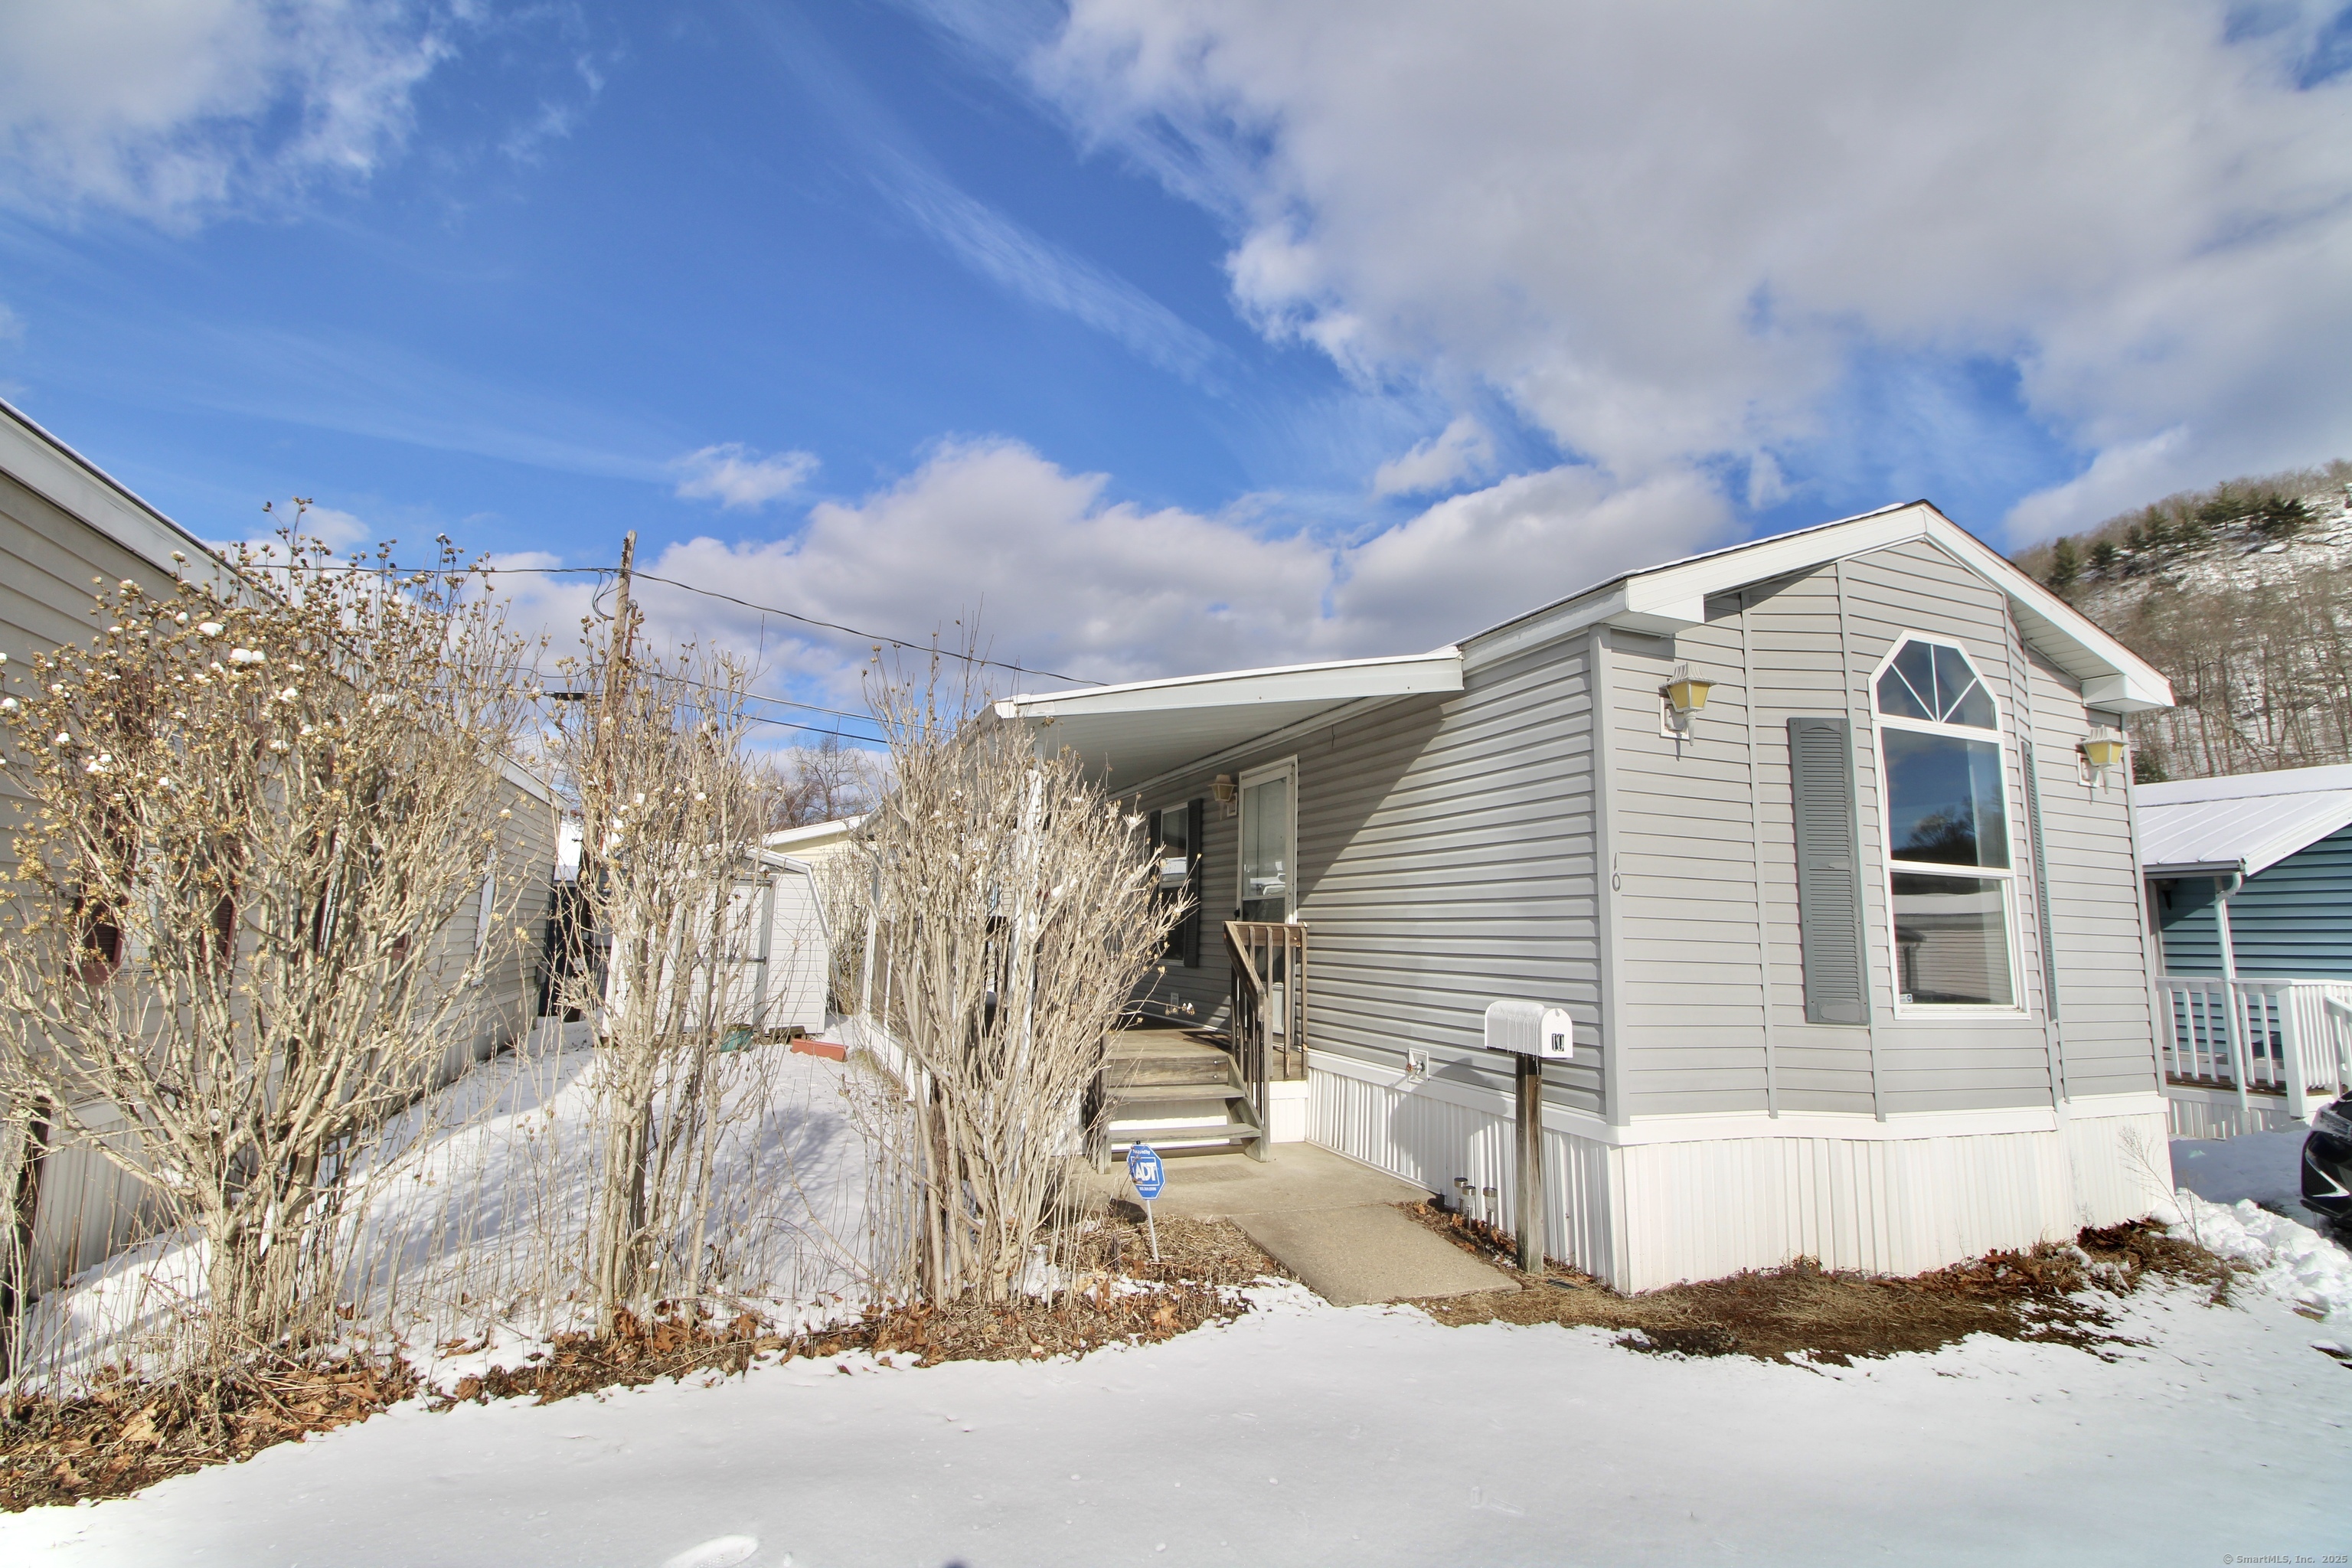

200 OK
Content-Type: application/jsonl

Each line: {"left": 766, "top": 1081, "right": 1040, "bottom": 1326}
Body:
{"left": 0, "top": 1206, "right": 1279, "bottom": 1514}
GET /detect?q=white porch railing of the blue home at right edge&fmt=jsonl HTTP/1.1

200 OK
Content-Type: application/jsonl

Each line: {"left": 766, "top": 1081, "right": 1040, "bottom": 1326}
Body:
{"left": 2159, "top": 975, "right": 2352, "bottom": 1122}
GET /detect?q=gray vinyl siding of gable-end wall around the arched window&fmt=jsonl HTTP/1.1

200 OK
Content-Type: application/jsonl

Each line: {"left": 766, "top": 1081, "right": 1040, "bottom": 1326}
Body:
{"left": 1609, "top": 543, "right": 2154, "bottom": 1116}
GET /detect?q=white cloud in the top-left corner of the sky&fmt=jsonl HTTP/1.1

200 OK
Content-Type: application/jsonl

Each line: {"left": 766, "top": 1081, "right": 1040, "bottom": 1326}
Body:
{"left": 0, "top": 0, "right": 449, "bottom": 224}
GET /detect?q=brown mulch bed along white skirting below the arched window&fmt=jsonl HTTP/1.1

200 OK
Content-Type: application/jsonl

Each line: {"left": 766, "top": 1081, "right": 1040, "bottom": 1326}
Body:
{"left": 1406, "top": 1206, "right": 2242, "bottom": 1366}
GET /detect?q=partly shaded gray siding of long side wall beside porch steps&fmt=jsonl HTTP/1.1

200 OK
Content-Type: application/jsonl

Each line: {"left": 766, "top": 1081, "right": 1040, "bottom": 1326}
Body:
{"left": 1136, "top": 639, "right": 1602, "bottom": 1112}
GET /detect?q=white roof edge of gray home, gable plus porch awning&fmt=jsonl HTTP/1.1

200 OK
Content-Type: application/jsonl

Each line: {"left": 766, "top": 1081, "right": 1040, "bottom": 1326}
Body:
{"left": 990, "top": 501, "right": 2174, "bottom": 790}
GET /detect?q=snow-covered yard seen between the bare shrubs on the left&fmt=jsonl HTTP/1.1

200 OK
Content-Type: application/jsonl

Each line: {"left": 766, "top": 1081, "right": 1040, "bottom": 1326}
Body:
{"left": 9, "top": 1044, "right": 871, "bottom": 1390}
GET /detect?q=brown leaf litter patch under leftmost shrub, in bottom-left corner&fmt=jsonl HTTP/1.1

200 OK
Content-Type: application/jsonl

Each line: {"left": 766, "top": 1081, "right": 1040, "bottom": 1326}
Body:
{"left": 0, "top": 1357, "right": 419, "bottom": 1514}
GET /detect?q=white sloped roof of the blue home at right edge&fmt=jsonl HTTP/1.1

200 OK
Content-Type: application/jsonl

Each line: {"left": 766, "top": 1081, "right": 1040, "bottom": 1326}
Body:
{"left": 2131, "top": 766, "right": 2352, "bottom": 877}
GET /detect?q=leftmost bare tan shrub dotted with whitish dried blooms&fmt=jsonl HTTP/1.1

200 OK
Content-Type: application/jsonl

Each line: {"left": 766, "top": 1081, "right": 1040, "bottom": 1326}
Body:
{"left": 0, "top": 534, "right": 529, "bottom": 1357}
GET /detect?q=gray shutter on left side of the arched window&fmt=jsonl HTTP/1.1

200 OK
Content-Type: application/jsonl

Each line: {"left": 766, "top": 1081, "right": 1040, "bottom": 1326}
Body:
{"left": 1788, "top": 720, "right": 1870, "bottom": 1023}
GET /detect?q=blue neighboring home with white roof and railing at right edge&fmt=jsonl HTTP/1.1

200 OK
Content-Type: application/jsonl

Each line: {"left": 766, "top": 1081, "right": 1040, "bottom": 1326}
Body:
{"left": 2131, "top": 766, "right": 2352, "bottom": 1138}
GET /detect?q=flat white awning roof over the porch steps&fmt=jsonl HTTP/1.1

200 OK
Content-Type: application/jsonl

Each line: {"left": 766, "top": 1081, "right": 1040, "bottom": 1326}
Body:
{"left": 990, "top": 646, "right": 1463, "bottom": 795}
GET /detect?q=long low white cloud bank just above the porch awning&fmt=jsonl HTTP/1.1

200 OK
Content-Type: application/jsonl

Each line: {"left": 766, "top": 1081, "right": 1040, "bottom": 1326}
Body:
{"left": 541, "top": 439, "right": 1729, "bottom": 707}
